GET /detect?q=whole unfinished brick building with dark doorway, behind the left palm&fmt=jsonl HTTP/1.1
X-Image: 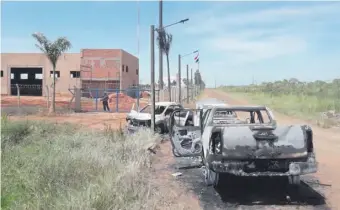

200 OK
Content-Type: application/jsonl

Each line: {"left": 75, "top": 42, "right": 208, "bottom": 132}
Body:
{"left": 1, "top": 49, "right": 139, "bottom": 96}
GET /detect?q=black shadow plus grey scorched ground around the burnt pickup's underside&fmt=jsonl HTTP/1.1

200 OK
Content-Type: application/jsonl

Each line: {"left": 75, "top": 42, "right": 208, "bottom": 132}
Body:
{"left": 173, "top": 158, "right": 330, "bottom": 210}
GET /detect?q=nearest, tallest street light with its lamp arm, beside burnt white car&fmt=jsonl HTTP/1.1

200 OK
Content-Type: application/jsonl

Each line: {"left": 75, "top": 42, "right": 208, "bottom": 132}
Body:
{"left": 150, "top": 18, "right": 189, "bottom": 131}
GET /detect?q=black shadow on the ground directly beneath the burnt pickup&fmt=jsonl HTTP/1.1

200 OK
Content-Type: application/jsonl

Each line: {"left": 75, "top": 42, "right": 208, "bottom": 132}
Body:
{"left": 216, "top": 175, "right": 325, "bottom": 206}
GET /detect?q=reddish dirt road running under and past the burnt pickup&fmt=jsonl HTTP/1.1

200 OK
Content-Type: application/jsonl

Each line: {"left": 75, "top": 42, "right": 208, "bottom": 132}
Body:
{"left": 160, "top": 89, "right": 340, "bottom": 210}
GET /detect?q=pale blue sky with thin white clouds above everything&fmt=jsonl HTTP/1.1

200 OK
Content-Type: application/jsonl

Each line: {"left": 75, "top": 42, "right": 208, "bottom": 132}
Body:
{"left": 1, "top": 1, "right": 340, "bottom": 86}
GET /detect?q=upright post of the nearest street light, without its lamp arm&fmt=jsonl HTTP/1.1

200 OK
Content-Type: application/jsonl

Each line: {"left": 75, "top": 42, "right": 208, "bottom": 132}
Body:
{"left": 150, "top": 25, "right": 155, "bottom": 132}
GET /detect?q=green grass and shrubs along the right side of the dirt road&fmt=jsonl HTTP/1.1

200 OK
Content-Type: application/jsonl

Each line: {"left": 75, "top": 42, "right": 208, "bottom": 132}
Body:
{"left": 222, "top": 79, "right": 340, "bottom": 119}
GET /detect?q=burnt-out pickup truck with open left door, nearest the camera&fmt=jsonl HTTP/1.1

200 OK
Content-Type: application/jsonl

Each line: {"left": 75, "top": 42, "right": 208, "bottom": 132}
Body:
{"left": 170, "top": 106, "right": 317, "bottom": 186}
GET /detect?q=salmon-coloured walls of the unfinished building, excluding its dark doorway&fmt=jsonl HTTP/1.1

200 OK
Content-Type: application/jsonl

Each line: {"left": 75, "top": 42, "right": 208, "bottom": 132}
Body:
{"left": 1, "top": 49, "right": 139, "bottom": 95}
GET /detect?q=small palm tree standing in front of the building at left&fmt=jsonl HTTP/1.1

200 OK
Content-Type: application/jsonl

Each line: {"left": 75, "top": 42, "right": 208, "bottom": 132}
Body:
{"left": 32, "top": 33, "right": 72, "bottom": 113}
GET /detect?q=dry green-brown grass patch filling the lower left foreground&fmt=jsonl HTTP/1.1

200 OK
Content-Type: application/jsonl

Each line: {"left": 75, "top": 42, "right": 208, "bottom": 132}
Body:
{"left": 1, "top": 117, "right": 181, "bottom": 210}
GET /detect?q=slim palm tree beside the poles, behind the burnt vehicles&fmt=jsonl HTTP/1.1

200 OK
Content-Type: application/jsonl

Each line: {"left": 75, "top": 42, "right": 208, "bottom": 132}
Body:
{"left": 157, "top": 29, "right": 172, "bottom": 101}
